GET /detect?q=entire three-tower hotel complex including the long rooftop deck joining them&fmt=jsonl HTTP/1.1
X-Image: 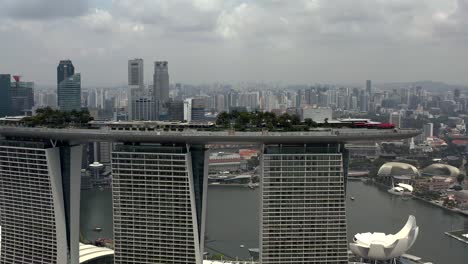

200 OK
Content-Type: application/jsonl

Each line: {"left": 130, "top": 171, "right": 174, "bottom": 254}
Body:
{"left": 0, "top": 122, "right": 419, "bottom": 264}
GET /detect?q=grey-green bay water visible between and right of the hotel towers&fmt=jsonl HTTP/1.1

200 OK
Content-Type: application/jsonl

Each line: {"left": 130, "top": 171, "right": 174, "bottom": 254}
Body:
{"left": 81, "top": 182, "right": 468, "bottom": 264}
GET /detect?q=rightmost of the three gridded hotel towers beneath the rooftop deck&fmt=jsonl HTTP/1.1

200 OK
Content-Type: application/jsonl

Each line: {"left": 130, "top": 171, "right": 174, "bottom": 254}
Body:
{"left": 260, "top": 143, "right": 348, "bottom": 264}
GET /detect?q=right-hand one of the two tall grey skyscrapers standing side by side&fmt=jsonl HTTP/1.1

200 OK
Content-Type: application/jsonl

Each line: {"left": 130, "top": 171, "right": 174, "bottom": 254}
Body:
{"left": 153, "top": 61, "right": 169, "bottom": 117}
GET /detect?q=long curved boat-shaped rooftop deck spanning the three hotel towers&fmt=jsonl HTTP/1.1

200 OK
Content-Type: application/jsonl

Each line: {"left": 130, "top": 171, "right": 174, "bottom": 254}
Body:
{"left": 0, "top": 126, "right": 421, "bottom": 144}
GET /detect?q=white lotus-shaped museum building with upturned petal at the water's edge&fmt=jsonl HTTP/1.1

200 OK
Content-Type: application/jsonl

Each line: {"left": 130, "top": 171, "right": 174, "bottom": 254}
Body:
{"left": 349, "top": 215, "right": 419, "bottom": 260}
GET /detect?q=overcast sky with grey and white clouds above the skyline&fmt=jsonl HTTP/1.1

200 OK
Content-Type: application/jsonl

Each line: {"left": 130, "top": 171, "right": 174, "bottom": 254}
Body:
{"left": 0, "top": 0, "right": 468, "bottom": 86}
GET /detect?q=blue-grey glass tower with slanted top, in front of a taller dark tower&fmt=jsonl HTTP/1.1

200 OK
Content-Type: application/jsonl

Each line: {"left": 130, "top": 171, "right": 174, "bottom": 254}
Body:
{"left": 57, "top": 73, "right": 81, "bottom": 111}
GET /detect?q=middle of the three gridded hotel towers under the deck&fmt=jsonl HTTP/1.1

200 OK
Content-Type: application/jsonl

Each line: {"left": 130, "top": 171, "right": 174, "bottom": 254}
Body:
{"left": 112, "top": 143, "right": 208, "bottom": 264}
